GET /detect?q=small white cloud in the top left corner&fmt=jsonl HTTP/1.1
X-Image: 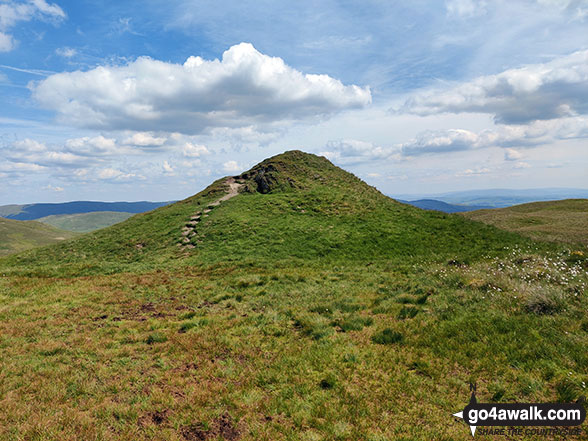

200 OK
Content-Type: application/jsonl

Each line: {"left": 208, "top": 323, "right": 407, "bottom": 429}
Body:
{"left": 0, "top": 0, "right": 66, "bottom": 52}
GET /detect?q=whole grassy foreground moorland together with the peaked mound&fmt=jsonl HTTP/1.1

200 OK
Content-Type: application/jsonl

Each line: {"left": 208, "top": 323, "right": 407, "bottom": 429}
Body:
{"left": 0, "top": 151, "right": 588, "bottom": 441}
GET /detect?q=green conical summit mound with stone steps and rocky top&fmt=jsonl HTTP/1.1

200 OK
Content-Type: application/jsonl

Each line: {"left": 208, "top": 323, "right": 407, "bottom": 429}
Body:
{"left": 2, "top": 150, "right": 521, "bottom": 274}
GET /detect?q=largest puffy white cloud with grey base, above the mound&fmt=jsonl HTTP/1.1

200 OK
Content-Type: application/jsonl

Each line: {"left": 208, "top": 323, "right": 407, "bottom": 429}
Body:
{"left": 30, "top": 43, "right": 371, "bottom": 134}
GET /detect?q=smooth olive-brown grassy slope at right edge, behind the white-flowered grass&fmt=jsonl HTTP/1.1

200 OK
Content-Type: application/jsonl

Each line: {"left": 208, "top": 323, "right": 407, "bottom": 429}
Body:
{"left": 464, "top": 199, "right": 588, "bottom": 245}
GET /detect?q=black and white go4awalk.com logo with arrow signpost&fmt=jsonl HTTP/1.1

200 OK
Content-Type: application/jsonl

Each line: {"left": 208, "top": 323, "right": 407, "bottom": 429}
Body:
{"left": 453, "top": 384, "right": 586, "bottom": 436}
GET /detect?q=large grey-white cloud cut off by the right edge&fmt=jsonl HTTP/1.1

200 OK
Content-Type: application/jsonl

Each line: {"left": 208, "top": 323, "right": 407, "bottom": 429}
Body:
{"left": 399, "top": 51, "right": 588, "bottom": 124}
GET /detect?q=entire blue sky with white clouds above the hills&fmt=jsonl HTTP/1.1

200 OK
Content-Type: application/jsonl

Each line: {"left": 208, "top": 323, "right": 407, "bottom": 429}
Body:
{"left": 0, "top": 0, "right": 588, "bottom": 205}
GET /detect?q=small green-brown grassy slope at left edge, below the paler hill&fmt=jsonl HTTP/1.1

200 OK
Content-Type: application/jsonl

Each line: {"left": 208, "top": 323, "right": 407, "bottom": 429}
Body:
{"left": 0, "top": 218, "right": 74, "bottom": 256}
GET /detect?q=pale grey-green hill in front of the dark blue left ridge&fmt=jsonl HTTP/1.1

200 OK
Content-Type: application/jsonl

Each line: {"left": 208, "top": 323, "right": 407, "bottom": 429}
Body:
{"left": 37, "top": 211, "right": 134, "bottom": 233}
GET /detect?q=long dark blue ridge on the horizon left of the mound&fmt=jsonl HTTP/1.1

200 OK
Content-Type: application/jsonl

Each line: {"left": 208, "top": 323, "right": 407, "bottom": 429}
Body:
{"left": 0, "top": 201, "right": 171, "bottom": 220}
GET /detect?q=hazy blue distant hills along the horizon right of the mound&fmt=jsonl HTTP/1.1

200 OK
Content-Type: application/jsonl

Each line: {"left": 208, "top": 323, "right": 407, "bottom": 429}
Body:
{"left": 393, "top": 188, "right": 588, "bottom": 208}
